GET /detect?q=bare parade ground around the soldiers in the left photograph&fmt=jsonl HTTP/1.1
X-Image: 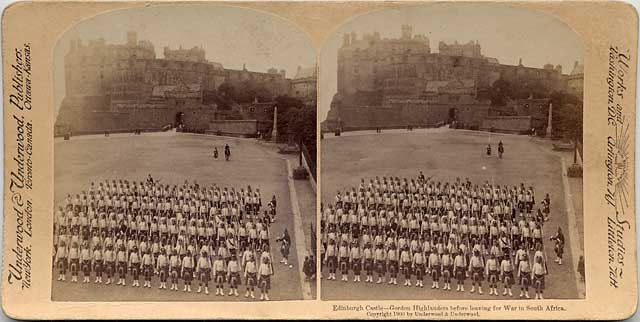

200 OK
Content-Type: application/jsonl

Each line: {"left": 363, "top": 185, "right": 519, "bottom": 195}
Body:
{"left": 52, "top": 133, "right": 308, "bottom": 301}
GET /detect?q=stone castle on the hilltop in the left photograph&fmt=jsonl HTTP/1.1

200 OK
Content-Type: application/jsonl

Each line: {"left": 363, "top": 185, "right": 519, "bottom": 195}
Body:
{"left": 55, "top": 32, "right": 315, "bottom": 134}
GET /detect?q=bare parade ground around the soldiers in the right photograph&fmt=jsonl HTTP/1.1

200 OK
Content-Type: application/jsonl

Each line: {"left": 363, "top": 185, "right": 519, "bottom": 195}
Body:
{"left": 321, "top": 129, "right": 583, "bottom": 300}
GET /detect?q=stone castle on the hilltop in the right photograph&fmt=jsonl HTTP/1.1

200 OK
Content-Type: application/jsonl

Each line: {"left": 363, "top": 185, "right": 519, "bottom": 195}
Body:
{"left": 323, "top": 25, "right": 583, "bottom": 132}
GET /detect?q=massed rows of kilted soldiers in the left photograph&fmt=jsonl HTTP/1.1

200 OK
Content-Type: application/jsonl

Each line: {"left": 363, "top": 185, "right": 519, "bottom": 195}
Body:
{"left": 53, "top": 175, "right": 284, "bottom": 300}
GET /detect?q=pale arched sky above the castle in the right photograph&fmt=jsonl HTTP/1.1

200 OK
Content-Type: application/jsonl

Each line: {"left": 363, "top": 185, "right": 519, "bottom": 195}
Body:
{"left": 318, "top": 3, "right": 583, "bottom": 120}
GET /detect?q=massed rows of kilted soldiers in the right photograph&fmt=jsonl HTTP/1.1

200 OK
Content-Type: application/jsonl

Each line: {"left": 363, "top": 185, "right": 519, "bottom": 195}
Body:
{"left": 321, "top": 172, "right": 564, "bottom": 299}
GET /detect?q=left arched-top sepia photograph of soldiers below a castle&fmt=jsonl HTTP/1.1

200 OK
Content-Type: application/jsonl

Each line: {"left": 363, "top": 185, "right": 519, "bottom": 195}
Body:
{"left": 51, "top": 5, "right": 317, "bottom": 302}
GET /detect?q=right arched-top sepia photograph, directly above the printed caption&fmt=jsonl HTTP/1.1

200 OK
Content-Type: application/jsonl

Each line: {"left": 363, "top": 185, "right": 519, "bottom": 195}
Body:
{"left": 318, "top": 3, "right": 589, "bottom": 301}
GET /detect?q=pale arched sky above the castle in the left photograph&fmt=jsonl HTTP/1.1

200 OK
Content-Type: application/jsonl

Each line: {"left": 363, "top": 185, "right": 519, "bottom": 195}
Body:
{"left": 54, "top": 3, "right": 316, "bottom": 112}
